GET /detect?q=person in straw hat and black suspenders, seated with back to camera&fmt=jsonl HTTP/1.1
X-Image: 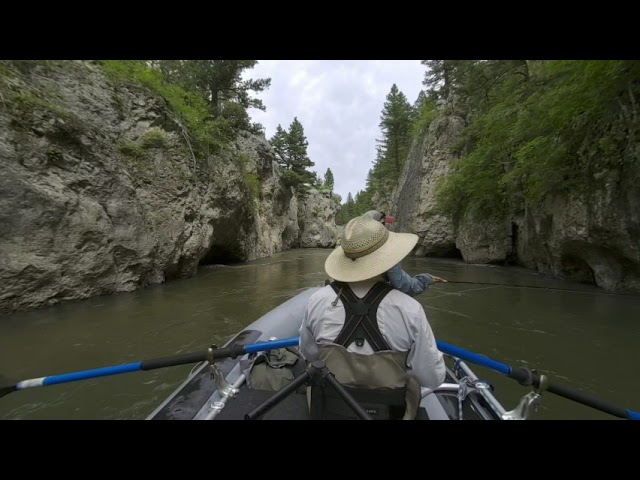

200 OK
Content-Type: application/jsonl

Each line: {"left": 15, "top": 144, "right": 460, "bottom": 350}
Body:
{"left": 300, "top": 215, "right": 445, "bottom": 419}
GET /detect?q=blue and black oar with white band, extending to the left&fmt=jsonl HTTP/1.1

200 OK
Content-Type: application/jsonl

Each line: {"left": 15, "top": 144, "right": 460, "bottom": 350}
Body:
{"left": 0, "top": 337, "right": 300, "bottom": 398}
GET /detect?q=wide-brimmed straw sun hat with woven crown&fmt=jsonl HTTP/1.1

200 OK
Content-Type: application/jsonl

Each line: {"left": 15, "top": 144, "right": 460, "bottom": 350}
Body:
{"left": 324, "top": 216, "right": 418, "bottom": 282}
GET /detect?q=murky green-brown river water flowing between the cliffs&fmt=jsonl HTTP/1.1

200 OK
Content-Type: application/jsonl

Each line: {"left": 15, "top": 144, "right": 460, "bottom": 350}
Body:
{"left": 0, "top": 249, "right": 640, "bottom": 420}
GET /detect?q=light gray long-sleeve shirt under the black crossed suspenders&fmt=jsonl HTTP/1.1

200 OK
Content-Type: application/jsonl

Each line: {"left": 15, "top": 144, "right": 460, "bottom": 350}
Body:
{"left": 300, "top": 279, "right": 446, "bottom": 388}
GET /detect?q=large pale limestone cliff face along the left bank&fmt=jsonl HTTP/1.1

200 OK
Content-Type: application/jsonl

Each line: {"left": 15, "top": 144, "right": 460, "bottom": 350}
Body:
{"left": 0, "top": 61, "right": 335, "bottom": 313}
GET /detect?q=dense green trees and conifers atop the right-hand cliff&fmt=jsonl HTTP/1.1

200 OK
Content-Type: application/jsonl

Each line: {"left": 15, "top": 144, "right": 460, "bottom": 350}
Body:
{"left": 336, "top": 60, "right": 640, "bottom": 224}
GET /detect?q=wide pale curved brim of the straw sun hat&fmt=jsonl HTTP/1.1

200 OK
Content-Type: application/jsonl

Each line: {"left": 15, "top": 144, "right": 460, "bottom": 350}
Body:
{"left": 324, "top": 232, "right": 418, "bottom": 282}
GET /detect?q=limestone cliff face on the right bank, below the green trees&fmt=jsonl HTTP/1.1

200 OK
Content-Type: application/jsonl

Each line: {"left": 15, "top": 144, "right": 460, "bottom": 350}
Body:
{"left": 391, "top": 92, "right": 640, "bottom": 292}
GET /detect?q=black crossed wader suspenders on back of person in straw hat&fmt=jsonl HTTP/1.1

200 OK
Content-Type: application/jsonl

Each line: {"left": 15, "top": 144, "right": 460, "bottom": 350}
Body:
{"left": 331, "top": 281, "right": 393, "bottom": 352}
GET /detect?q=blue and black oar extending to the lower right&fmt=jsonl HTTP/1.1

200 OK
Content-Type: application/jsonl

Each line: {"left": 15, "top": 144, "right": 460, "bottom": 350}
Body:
{"left": 436, "top": 341, "right": 640, "bottom": 420}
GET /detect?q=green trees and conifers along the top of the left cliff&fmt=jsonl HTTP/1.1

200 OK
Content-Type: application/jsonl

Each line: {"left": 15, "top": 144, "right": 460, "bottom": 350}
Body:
{"left": 100, "top": 60, "right": 334, "bottom": 193}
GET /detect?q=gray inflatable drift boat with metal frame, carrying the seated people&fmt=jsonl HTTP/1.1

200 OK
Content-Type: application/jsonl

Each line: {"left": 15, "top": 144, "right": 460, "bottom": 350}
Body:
{"left": 147, "top": 287, "right": 539, "bottom": 420}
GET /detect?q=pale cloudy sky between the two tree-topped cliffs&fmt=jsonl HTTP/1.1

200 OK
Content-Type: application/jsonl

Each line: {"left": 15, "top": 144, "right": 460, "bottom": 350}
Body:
{"left": 244, "top": 60, "right": 426, "bottom": 202}
